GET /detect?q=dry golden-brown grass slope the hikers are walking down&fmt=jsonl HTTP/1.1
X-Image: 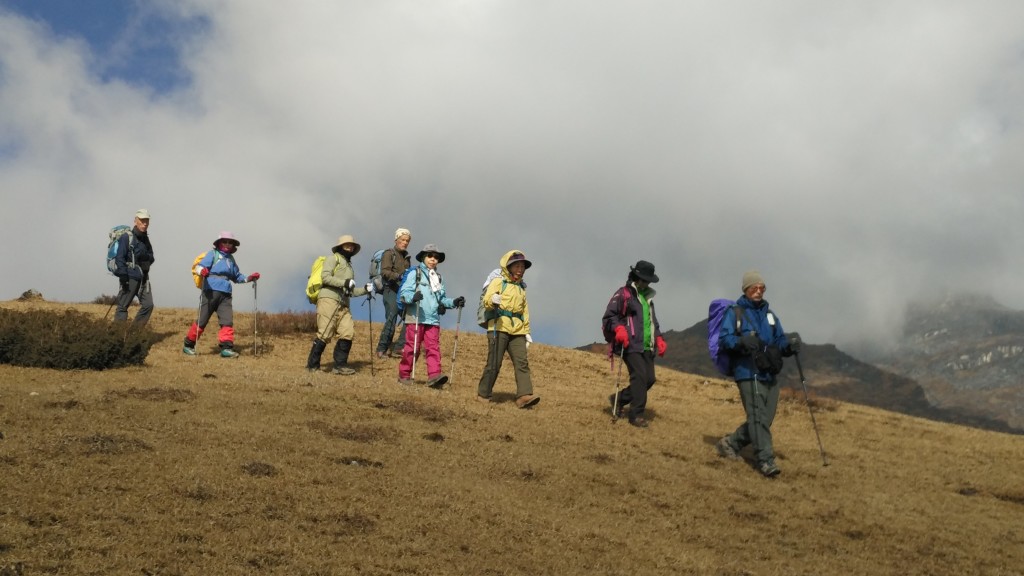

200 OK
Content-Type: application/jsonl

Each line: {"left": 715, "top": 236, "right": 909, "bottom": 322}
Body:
{"left": 0, "top": 302, "right": 1024, "bottom": 576}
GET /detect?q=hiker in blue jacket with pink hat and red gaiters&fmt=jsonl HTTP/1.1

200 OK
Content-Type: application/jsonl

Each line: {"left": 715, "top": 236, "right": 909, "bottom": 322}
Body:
{"left": 181, "top": 232, "right": 259, "bottom": 358}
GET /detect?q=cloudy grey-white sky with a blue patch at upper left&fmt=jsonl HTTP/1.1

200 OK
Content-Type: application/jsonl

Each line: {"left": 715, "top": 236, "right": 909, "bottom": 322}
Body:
{"left": 0, "top": 0, "right": 1024, "bottom": 346}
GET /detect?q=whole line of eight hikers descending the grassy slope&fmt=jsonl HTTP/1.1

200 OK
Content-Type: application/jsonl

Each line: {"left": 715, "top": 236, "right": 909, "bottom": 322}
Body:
{"left": 114, "top": 209, "right": 802, "bottom": 478}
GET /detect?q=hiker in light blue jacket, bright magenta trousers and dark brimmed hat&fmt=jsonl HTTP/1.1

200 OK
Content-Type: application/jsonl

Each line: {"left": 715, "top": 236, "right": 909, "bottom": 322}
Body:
{"left": 398, "top": 244, "right": 466, "bottom": 388}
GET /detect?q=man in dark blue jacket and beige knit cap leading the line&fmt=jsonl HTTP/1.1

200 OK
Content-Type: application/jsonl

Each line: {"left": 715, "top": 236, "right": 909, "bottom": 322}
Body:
{"left": 716, "top": 271, "right": 801, "bottom": 478}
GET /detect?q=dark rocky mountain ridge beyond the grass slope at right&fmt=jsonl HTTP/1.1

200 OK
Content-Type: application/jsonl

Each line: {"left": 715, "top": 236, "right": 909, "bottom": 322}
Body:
{"left": 581, "top": 296, "right": 1024, "bottom": 434}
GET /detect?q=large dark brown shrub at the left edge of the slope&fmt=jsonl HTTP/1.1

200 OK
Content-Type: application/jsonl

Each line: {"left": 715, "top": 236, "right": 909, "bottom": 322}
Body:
{"left": 0, "top": 310, "right": 161, "bottom": 370}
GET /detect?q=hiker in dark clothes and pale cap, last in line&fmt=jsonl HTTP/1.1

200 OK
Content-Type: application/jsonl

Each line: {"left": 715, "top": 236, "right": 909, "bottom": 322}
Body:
{"left": 108, "top": 208, "right": 157, "bottom": 327}
